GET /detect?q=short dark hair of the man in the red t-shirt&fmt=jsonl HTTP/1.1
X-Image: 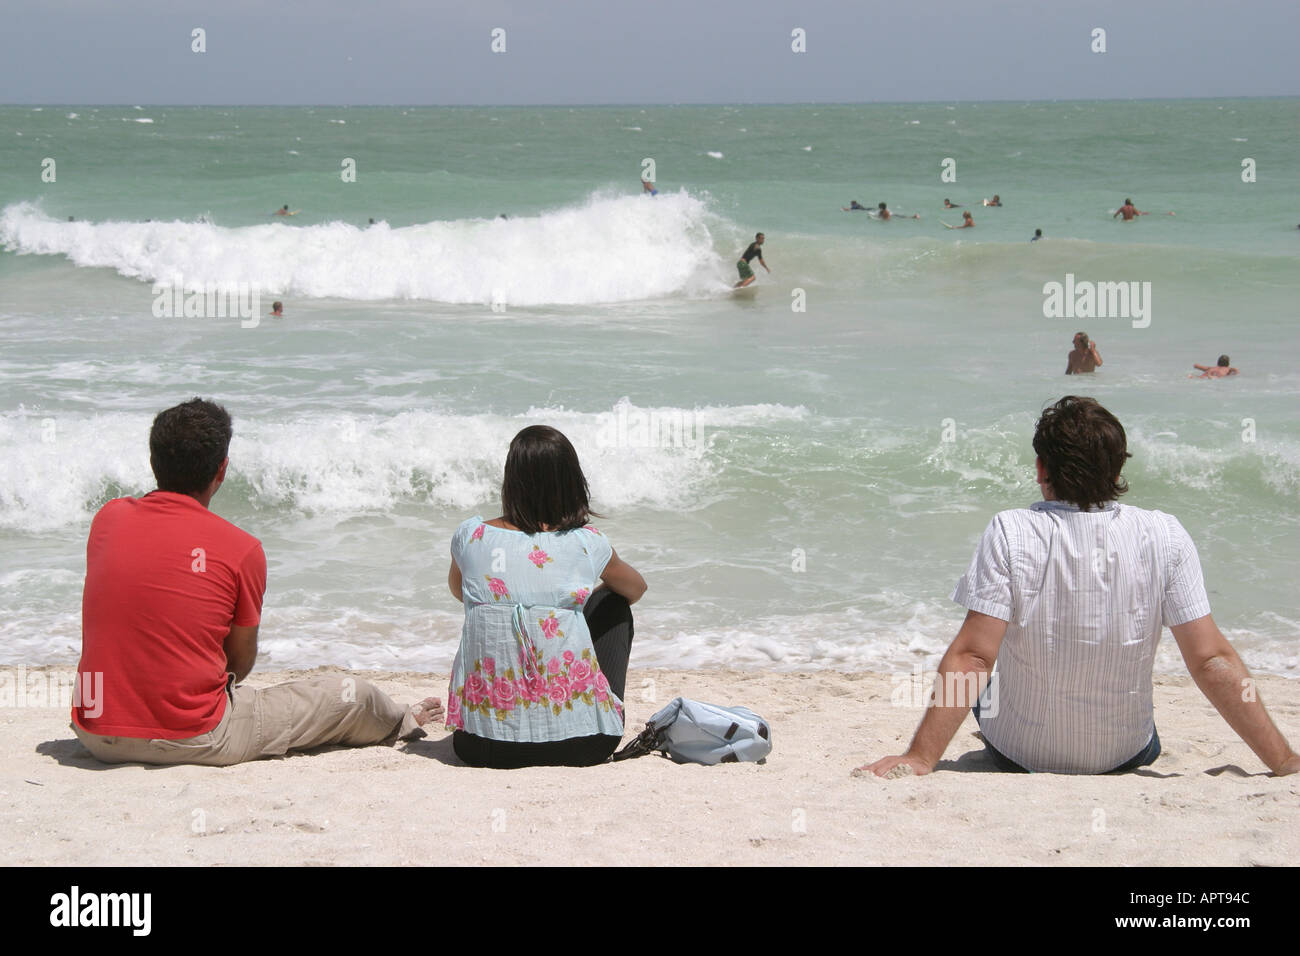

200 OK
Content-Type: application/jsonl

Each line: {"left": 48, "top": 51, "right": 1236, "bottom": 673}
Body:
{"left": 150, "top": 398, "right": 233, "bottom": 494}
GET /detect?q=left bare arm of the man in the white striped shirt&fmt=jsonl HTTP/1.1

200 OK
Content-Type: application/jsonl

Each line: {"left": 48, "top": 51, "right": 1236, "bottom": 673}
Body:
{"left": 858, "top": 611, "right": 1006, "bottom": 777}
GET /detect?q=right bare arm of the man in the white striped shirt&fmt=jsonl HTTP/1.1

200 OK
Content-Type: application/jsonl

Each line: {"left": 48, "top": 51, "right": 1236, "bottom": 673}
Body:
{"left": 1170, "top": 614, "right": 1300, "bottom": 777}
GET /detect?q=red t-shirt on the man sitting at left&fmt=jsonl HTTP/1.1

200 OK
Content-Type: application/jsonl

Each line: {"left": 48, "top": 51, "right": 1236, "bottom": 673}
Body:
{"left": 73, "top": 492, "right": 267, "bottom": 740}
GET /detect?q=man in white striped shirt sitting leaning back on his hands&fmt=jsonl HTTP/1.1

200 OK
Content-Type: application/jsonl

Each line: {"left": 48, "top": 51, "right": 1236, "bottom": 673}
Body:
{"left": 865, "top": 395, "right": 1300, "bottom": 777}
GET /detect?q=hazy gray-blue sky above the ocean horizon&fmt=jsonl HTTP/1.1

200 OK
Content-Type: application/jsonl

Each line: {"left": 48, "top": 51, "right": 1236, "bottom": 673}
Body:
{"left": 0, "top": 0, "right": 1300, "bottom": 105}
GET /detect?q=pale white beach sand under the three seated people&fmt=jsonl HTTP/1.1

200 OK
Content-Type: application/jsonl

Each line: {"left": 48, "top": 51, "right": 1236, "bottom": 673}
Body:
{"left": 0, "top": 670, "right": 1300, "bottom": 866}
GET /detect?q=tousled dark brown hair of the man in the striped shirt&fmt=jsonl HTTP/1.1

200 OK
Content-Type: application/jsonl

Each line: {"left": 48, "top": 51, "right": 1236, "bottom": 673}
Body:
{"left": 1034, "top": 395, "right": 1131, "bottom": 511}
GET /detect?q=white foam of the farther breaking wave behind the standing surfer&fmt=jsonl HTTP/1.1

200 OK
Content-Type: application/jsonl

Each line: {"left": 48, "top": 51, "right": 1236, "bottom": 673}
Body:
{"left": 0, "top": 191, "right": 723, "bottom": 307}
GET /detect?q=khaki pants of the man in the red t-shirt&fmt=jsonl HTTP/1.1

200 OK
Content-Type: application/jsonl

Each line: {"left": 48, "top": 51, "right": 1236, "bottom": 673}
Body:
{"left": 73, "top": 678, "right": 424, "bottom": 766}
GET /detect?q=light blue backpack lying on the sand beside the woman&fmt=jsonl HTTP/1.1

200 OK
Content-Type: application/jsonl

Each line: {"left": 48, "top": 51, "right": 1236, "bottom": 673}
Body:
{"left": 614, "top": 697, "right": 772, "bottom": 766}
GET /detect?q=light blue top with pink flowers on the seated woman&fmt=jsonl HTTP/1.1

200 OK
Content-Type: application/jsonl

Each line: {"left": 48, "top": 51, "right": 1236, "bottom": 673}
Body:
{"left": 447, "top": 515, "right": 623, "bottom": 743}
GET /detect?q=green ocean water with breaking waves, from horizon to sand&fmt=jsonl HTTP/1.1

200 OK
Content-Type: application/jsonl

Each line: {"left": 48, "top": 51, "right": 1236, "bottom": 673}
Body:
{"left": 0, "top": 99, "right": 1300, "bottom": 676}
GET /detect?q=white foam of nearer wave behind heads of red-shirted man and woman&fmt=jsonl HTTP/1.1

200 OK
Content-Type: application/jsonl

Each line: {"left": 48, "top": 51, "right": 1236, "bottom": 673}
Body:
{"left": 0, "top": 401, "right": 807, "bottom": 533}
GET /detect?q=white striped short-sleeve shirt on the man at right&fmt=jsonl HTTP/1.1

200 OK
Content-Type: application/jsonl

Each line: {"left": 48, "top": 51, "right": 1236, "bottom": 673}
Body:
{"left": 953, "top": 501, "right": 1210, "bottom": 774}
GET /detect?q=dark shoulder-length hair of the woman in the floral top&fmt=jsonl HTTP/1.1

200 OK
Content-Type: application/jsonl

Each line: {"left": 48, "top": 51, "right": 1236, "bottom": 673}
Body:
{"left": 501, "top": 425, "right": 601, "bottom": 535}
